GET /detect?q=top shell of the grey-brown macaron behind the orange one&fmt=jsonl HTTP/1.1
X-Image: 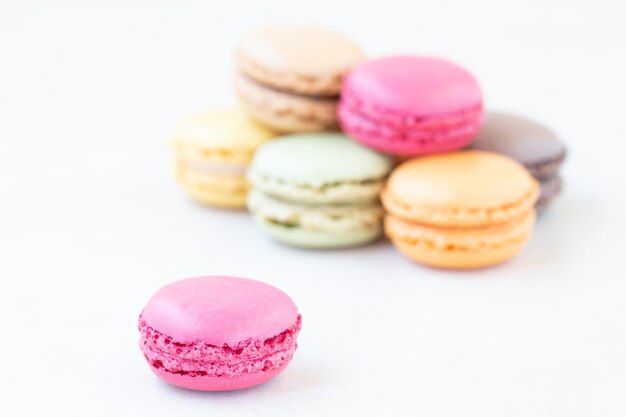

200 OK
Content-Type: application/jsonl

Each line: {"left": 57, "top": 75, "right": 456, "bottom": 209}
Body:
{"left": 470, "top": 112, "right": 566, "bottom": 174}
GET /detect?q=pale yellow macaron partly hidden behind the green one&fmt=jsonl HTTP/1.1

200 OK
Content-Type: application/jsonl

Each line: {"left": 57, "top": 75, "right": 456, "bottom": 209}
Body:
{"left": 172, "top": 109, "right": 276, "bottom": 208}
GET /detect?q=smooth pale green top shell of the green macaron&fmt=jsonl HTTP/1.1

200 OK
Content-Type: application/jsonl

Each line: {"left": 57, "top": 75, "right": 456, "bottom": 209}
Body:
{"left": 249, "top": 133, "right": 391, "bottom": 187}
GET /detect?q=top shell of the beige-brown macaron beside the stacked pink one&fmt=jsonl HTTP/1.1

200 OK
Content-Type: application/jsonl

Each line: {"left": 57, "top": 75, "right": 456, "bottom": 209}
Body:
{"left": 237, "top": 25, "right": 364, "bottom": 95}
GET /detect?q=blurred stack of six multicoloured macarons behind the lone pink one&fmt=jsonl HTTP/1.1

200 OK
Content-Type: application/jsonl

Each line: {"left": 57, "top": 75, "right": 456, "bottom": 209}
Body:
{"left": 167, "top": 25, "right": 565, "bottom": 268}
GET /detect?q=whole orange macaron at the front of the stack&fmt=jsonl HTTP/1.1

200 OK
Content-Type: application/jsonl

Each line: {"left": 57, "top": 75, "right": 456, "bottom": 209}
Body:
{"left": 382, "top": 151, "right": 539, "bottom": 269}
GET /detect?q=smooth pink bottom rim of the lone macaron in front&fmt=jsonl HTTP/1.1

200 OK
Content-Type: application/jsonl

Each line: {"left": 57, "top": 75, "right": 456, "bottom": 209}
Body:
{"left": 150, "top": 362, "right": 289, "bottom": 391}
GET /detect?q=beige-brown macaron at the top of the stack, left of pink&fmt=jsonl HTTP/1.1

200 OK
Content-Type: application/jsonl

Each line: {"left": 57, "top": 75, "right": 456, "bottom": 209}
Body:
{"left": 234, "top": 25, "right": 364, "bottom": 133}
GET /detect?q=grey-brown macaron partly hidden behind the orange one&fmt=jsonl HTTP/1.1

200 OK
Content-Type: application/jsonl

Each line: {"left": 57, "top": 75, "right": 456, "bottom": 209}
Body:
{"left": 470, "top": 112, "right": 567, "bottom": 210}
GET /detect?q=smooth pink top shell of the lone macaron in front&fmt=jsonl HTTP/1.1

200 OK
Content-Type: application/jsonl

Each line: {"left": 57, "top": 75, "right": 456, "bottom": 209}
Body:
{"left": 142, "top": 276, "right": 298, "bottom": 347}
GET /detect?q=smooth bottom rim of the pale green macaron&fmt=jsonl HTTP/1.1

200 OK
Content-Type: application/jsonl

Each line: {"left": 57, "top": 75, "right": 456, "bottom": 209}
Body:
{"left": 255, "top": 217, "right": 383, "bottom": 249}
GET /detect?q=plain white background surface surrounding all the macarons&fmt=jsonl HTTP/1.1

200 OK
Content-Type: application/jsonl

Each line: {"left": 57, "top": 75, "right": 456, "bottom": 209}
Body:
{"left": 0, "top": 0, "right": 626, "bottom": 417}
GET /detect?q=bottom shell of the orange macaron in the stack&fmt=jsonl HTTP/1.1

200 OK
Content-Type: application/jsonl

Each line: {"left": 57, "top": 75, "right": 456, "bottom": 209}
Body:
{"left": 384, "top": 210, "right": 536, "bottom": 269}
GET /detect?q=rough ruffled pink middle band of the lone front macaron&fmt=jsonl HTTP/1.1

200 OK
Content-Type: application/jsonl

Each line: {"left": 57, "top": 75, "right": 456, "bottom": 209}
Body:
{"left": 138, "top": 315, "right": 302, "bottom": 378}
